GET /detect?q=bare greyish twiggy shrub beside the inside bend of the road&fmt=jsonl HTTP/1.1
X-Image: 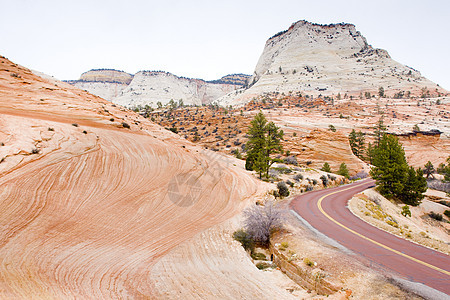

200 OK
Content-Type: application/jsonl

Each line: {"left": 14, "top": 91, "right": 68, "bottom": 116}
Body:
{"left": 244, "top": 201, "right": 283, "bottom": 246}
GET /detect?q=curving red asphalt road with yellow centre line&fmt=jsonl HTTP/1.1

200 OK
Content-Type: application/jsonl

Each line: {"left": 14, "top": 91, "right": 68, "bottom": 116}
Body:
{"left": 290, "top": 179, "right": 450, "bottom": 295}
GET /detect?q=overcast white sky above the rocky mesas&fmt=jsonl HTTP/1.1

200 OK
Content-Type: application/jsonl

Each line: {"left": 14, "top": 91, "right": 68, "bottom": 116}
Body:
{"left": 0, "top": 0, "right": 450, "bottom": 90}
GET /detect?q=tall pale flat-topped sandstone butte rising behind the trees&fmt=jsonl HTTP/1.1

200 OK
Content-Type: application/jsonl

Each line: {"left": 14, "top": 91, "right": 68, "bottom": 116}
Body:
{"left": 220, "top": 21, "right": 446, "bottom": 104}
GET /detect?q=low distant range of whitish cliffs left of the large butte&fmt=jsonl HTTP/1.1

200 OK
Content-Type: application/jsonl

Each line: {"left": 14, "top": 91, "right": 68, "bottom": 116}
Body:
{"left": 68, "top": 69, "right": 249, "bottom": 107}
